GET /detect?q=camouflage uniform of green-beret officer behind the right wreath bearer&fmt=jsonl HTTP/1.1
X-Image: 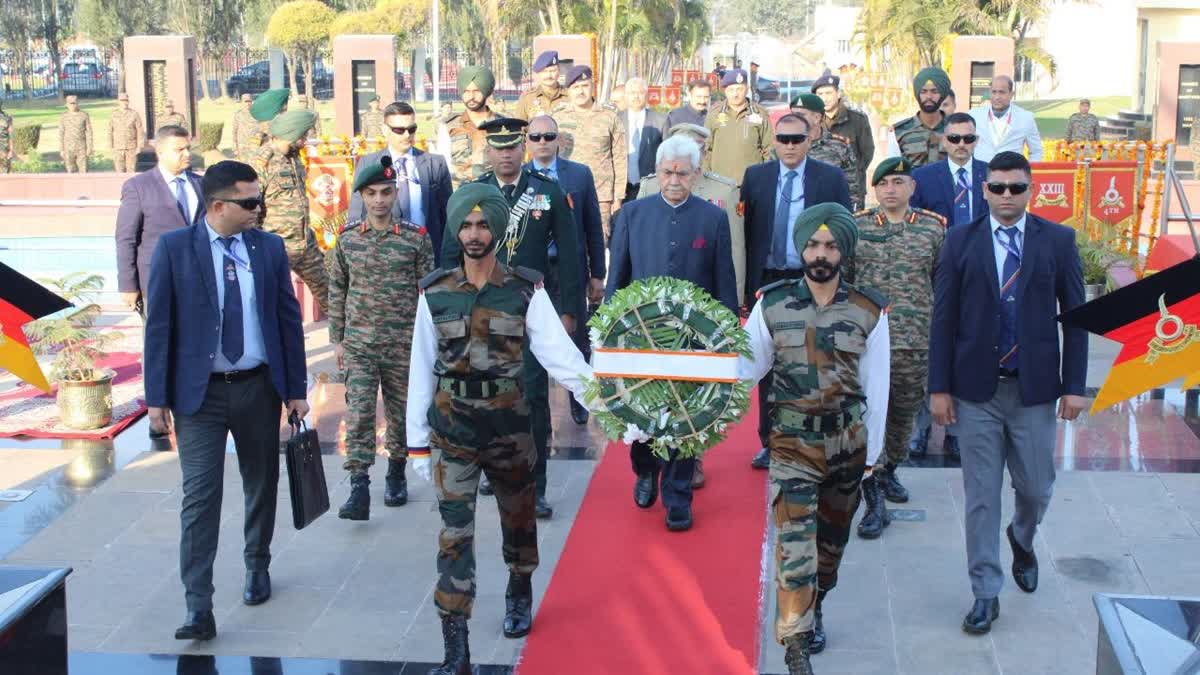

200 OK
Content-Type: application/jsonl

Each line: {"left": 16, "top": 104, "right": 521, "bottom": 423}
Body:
{"left": 846, "top": 209, "right": 946, "bottom": 468}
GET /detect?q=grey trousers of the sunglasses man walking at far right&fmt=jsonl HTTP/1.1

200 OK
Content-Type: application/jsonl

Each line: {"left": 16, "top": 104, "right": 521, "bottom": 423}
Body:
{"left": 953, "top": 378, "right": 1056, "bottom": 599}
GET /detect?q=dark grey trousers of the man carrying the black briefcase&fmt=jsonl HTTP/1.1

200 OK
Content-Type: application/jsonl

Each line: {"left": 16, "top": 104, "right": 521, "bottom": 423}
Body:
{"left": 175, "top": 369, "right": 282, "bottom": 613}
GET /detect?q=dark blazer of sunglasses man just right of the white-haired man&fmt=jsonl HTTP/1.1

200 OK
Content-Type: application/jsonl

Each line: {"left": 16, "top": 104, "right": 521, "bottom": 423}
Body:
{"left": 742, "top": 157, "right": 851, "bottom": 306}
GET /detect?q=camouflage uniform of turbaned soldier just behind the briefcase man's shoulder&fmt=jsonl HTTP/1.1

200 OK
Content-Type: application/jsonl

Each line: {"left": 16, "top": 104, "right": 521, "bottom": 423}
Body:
{"left": 251, "top": 143, "right": 329, "bottom": 315}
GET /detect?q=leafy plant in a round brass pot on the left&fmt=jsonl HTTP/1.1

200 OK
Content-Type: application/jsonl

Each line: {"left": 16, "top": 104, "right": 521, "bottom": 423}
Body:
{"left": 26, "top": 271, "right": 115, "bottom": 429}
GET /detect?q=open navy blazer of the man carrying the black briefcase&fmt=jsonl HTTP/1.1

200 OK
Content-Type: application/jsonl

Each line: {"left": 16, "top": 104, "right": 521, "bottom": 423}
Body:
{"left": 143, "top": 221, "right": 307, "bottom": 415}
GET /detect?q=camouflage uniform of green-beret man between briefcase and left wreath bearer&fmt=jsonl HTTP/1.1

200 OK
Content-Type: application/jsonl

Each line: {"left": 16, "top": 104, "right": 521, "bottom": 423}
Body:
{"left": 329, "top": 222, "right": 433, "bottom": 472}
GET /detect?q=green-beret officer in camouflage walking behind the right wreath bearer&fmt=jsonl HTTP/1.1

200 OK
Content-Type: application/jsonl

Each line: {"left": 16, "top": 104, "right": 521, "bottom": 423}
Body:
{"left": 846, "top": 157, "right": 946, "bottom": 539}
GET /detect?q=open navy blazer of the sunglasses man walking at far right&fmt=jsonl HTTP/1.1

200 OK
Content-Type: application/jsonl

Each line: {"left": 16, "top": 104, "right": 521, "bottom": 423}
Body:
{"left": 929, "top": 214, "right": 1087, "bottom": 406}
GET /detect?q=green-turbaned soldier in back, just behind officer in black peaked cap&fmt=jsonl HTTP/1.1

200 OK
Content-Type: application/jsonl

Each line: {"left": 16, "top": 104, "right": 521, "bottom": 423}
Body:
{"left": 438, "top": 66, "right": 497, "bottom": 187}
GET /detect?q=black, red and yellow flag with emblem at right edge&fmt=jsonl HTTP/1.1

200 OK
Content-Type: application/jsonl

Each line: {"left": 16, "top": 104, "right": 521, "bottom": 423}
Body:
{"left": 1058, "top": 257, "right": 1200, "bottom": 414}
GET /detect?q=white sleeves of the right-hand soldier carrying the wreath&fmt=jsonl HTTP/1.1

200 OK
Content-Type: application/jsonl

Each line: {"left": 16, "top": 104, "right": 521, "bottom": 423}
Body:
{"left": 738, "top": 303, "right": 892, "bottom": 466}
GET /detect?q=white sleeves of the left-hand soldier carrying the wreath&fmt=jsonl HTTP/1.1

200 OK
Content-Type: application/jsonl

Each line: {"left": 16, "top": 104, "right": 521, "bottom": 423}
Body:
{"left": 404, "top": 288, "right": 602, "bottom": 448}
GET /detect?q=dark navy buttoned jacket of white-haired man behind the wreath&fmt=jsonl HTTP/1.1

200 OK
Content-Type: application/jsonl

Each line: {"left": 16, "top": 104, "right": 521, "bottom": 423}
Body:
{"left": 605, "top": 195, "right": 738, "bottom": 313}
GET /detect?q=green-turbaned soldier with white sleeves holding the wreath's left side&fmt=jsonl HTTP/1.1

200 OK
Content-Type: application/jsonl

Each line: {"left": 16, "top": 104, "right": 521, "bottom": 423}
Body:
{"left": 407, "top": 182, "right": 592, "bottom": 675}
